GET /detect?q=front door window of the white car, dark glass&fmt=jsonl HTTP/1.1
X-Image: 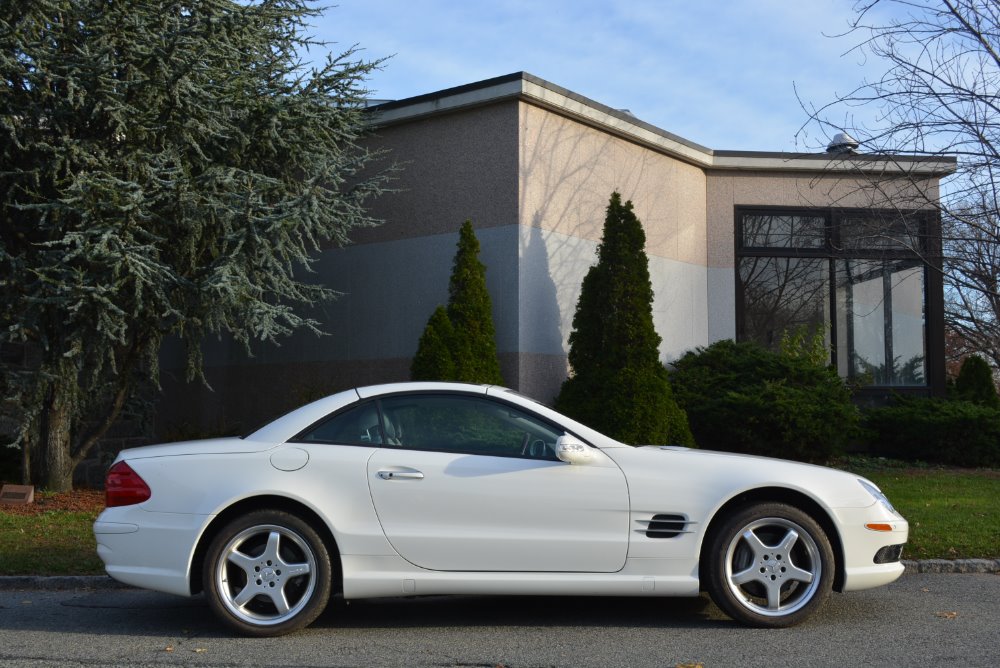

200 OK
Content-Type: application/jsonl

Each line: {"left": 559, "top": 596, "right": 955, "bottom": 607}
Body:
{"left": 379, "top": 394, "right": 562, "bottom": 460}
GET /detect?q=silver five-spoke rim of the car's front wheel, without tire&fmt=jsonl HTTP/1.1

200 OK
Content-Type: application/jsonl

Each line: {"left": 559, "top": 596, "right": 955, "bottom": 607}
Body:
{"left": 725, "top": 517, "right": 823, "bottom": 617}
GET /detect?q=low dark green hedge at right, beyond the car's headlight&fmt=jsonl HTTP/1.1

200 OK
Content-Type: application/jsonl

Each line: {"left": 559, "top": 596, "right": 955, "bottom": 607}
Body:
{"left": 864, "top": 398, "right": 1000, "bottom": 467}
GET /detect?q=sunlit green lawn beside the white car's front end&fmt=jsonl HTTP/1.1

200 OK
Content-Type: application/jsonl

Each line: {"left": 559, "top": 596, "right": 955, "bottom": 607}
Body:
{"left": 840, "top": 459, "right": 1000, "bottom": 559}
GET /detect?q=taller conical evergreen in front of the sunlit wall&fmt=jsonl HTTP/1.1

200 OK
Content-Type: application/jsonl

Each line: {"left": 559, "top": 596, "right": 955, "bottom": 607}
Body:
{"left": 556, "top": 192, "right": 693, "bottom": 445}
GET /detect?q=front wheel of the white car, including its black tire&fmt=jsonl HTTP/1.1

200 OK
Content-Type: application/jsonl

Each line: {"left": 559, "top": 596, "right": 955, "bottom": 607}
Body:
{"left": 702, "top": 503, "right": 834, "bottom": 628}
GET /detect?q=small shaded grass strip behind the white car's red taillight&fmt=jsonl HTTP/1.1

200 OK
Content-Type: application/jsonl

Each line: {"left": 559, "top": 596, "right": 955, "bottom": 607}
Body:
{"left": 0, "top": 510, "right": 104, "bottom": 575}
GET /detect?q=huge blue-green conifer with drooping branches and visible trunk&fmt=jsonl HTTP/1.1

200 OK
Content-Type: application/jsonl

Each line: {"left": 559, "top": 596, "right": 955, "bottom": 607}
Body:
{"left": 0, "top": 0, "right": 386, "bottom": 491}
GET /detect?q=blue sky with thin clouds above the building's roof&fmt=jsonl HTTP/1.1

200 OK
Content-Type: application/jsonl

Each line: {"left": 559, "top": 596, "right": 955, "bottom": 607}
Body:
{"left": 312, "top": 0, "right": 900, "bottom": 151}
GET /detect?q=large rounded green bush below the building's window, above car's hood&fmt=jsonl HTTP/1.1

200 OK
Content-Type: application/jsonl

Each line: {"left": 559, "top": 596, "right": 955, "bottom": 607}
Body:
{"left": 670, "top": 340, "right": 860, "bottom": 462}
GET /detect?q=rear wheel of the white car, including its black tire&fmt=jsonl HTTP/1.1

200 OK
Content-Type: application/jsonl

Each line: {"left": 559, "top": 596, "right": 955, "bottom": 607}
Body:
{"left": 202, "top": 510, "right": 332, "bottom": 637}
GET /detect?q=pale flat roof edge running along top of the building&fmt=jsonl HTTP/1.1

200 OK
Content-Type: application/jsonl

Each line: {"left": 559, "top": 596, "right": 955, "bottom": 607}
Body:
{"left": 368, "top": 72, "right": 957, "bottom": 176}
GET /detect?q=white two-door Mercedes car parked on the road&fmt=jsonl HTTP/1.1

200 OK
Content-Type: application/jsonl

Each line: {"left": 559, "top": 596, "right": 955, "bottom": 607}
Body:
{"left": 94, "top": 383, "right": 908, "bottom": 636}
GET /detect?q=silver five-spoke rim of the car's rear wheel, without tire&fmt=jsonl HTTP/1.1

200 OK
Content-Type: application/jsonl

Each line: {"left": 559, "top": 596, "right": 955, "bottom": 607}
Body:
{"left": 215, "top": 524, "right": 316, "bottom": 626}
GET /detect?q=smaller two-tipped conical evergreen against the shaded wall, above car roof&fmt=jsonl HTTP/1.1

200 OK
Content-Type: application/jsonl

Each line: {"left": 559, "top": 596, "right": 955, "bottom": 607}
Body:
{"left": 410, "top": 220, "right": 503, "bottom": 385}
